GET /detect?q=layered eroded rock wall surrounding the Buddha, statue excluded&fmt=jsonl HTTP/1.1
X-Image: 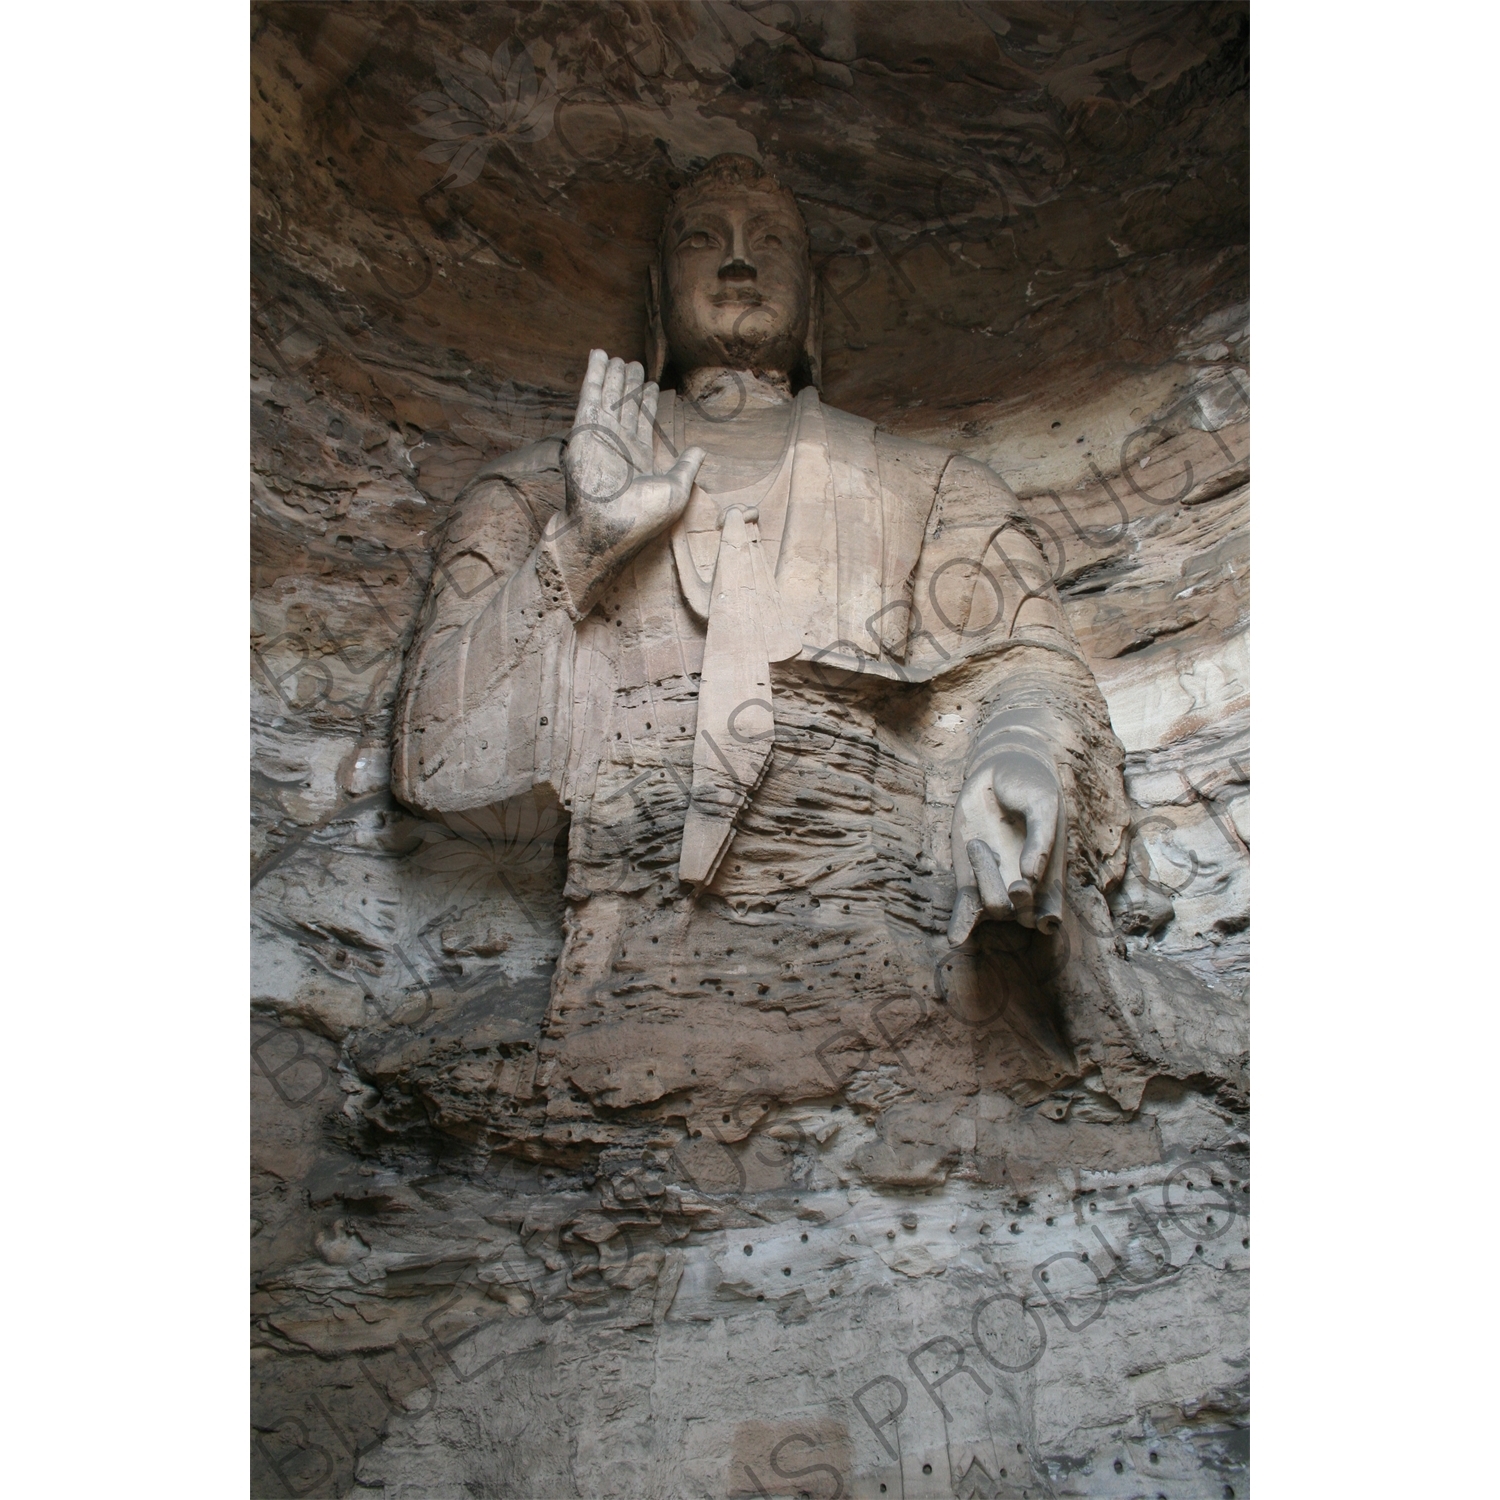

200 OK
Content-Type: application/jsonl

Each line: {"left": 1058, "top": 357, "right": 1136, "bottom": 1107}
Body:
{"left": 251, "top": 3, "right": 1250, "bottom": 1500}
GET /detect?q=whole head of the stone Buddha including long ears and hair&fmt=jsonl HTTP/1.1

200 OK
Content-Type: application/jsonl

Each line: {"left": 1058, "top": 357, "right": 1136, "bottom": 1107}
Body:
{"left": 648, "top": 155, "right": 821, "bottom": 387}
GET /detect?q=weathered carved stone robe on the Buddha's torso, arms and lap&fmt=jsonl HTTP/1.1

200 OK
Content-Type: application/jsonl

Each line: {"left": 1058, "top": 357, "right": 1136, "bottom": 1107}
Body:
{"left": 392, "top": 389, "right": 1130, "bottom": 1140}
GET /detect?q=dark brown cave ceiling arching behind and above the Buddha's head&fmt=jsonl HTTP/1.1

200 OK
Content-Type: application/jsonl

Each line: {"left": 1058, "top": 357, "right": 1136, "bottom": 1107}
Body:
{"left": 251, "top": 0, "right": 1250, "bottom": 449}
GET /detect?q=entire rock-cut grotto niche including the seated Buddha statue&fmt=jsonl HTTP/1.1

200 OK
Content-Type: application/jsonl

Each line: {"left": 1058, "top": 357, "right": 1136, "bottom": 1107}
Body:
{"left": 251, "top": 3, "right": 1250, "bottom": 1497}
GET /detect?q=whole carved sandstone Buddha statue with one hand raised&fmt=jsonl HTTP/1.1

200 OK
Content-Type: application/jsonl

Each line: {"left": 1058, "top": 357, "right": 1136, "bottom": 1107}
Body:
{"left": 393, "top": 156, "right": 1130, "bottom": 1145}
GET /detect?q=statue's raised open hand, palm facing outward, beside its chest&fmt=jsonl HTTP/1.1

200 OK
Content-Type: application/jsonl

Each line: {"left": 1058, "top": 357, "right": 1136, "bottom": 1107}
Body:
{"left": 563, "top": 350, "right": 705, "bottom": 566}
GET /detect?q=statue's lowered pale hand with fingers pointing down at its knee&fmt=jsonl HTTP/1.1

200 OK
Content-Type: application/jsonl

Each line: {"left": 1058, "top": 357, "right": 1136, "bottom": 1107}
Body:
{"left": 948, "top": 747, "right": 1068, "bottom": 947}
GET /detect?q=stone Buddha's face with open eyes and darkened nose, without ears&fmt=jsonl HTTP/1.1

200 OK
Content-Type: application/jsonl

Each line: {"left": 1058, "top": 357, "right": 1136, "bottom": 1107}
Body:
{"left": 662, "top": 188, "right": 812, "bottom": 375}
